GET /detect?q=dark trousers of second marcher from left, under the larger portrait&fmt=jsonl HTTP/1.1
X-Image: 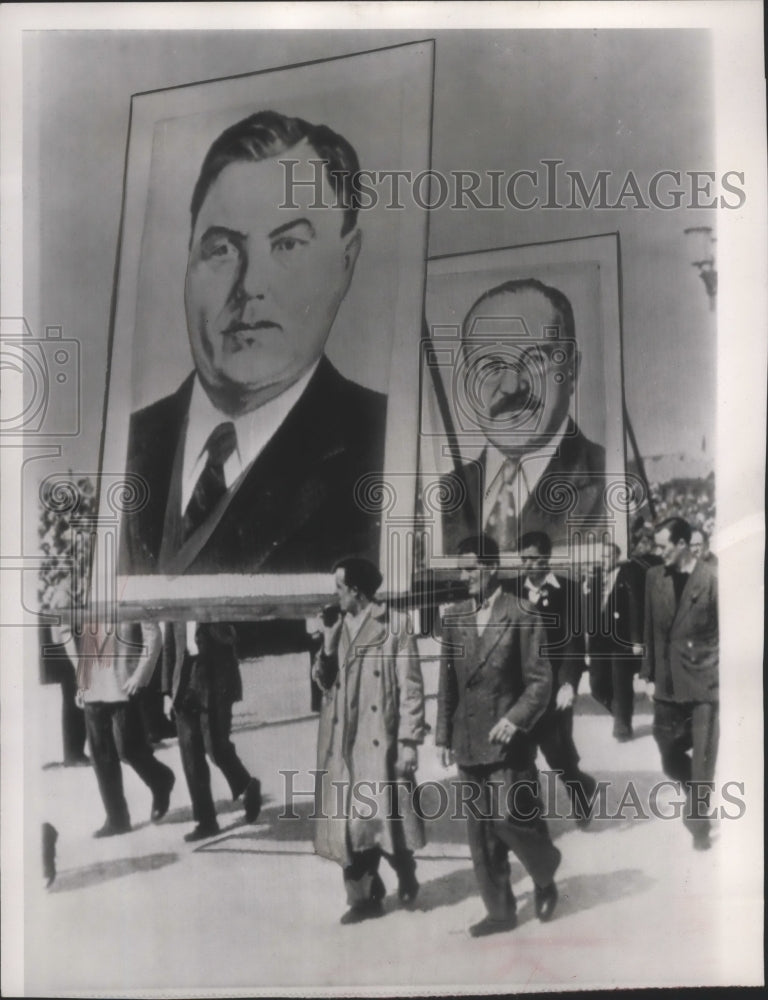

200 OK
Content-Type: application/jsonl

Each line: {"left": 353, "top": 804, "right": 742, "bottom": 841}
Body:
{"left": 176, "top": 690, "right": 251, "bottom": 826}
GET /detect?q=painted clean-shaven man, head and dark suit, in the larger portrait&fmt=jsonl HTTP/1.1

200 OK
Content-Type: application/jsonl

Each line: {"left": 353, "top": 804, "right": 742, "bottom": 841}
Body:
{"left": 120, "top": 111, "right": 387, "bottom": 574}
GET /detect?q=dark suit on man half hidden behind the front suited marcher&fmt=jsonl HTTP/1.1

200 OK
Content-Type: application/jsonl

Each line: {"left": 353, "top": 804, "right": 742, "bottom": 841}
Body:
{"left": 510, "top": 573, "right": 597, "bottom": 823}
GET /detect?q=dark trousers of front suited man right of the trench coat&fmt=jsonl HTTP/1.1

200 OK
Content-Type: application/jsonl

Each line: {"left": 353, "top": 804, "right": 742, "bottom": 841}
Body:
{"left": 459, "top": 765, "right": 560, "bottom": 920}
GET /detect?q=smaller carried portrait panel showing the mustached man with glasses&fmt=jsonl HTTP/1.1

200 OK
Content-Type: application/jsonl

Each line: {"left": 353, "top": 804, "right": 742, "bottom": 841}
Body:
{"left": 420, "top": 233, "right": 642, "bottom": 568}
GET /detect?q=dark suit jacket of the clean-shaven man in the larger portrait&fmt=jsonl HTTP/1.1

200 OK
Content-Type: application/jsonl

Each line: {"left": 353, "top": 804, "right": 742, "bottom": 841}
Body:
{"left": 120, "top": 357, "right": 386, "bottom": 574}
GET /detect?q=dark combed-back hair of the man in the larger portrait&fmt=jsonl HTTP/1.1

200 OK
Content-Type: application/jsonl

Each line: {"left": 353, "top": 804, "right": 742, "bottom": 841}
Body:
{"left": 190, "top": 111, "right": 360, "bottom": 236}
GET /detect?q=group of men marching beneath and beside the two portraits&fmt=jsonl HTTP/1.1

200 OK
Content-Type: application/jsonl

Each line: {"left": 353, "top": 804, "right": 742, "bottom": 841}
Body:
{"left": 39, "top": 517, "right": 718, "bottom": 937}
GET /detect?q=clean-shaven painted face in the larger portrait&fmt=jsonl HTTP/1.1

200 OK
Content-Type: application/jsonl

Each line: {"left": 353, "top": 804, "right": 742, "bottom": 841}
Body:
{"left": 184, "top": 142, "right": 360, "bottom": 415}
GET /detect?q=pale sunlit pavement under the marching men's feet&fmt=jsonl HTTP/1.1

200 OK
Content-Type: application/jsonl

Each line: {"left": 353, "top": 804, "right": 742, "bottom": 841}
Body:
{"left": 25, "top": 667, "right": 762, "bottom": 995}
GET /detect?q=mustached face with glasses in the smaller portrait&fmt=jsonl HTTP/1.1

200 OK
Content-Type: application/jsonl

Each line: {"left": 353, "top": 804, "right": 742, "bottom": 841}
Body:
{"left": 464, "top": 289, "right": 579, "bottom": 457}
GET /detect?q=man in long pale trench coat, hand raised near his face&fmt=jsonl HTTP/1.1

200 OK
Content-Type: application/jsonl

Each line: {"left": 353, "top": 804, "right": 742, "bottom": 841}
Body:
{"left": 313, "top": 558, "right": 425, "bottom": 924}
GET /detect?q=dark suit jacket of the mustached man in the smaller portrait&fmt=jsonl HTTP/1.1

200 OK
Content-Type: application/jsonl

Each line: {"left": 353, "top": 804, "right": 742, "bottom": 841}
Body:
{"left": 442, "top": 418, "right": 606, "bottom": 555}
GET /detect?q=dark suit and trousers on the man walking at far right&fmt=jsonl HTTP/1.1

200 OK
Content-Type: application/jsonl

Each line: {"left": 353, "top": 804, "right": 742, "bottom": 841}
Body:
{"left": 642, "top": 559, "right": 720, "bottom": 843}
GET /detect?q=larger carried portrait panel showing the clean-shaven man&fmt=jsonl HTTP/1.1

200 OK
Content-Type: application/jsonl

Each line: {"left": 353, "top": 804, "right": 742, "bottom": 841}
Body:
{"left": 95, "top": 42, "right": 433, "bottom": 615}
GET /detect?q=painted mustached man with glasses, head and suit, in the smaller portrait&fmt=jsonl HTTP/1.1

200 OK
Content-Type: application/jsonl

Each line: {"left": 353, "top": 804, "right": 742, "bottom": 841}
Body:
{"left": 443, "top": 278, "right": 606, "bottom": 554}
